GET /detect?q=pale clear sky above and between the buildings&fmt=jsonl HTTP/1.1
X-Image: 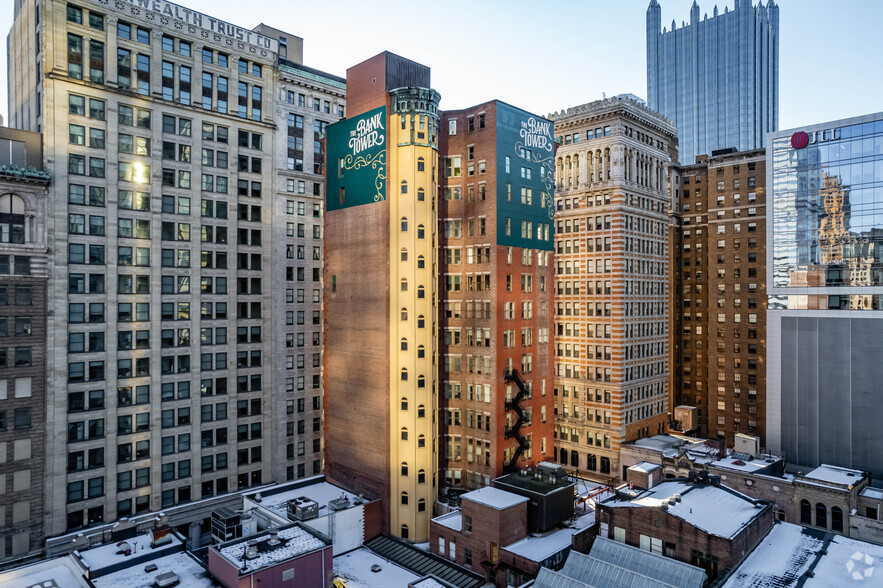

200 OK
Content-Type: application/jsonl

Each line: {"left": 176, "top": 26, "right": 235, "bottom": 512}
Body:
{"left": 0, "top": 0, "right": 883, "bottom": 129}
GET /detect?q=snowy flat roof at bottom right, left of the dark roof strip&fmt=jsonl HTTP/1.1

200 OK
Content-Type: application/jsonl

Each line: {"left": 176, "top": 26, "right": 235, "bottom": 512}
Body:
{"left": 723, "top": 523, "right": 824, "bottom": 588}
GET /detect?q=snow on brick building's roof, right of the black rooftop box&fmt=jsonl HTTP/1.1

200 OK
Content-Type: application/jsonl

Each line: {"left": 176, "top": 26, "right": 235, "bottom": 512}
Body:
{"left": 604, "top": 481, "right": 760, "bottom": 538}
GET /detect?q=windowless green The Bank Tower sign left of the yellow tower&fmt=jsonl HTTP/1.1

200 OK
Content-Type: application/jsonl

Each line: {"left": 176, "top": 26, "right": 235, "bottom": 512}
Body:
{"left": 325, "top": 106, "right": 387, "bottom": 210}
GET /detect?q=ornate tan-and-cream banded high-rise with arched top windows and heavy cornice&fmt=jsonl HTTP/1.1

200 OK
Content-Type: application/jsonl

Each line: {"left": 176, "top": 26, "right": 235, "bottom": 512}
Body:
{"left": 551, "top": 95, "right": 677, "bottom": 479}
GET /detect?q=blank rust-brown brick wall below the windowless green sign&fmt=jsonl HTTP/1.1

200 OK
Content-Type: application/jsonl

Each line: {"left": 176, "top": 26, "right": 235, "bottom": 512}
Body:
{"left": 324, "top": 201, "right": 390, "bottom": 512}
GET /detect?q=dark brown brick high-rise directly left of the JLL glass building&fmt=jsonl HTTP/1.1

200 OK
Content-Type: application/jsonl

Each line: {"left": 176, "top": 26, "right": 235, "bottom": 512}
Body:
{"left": 672, "top": 149, "right": 767, "bottom": 446}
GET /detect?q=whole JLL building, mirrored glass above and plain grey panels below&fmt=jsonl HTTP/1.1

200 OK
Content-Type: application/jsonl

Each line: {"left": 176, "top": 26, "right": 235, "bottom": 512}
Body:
{"left": 767, "top": 113, "right": 883, "bottom": 478}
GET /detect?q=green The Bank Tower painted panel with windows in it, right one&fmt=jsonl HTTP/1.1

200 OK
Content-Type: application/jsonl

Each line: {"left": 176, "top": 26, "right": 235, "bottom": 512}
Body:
{"left": 496, "top": 102, "right": 555, "bottom": 251}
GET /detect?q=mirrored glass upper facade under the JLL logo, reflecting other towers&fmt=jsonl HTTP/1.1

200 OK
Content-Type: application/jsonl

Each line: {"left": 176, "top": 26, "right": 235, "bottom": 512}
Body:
{"left": 770, "top": 115, "right": 883, "bottom": 310}
